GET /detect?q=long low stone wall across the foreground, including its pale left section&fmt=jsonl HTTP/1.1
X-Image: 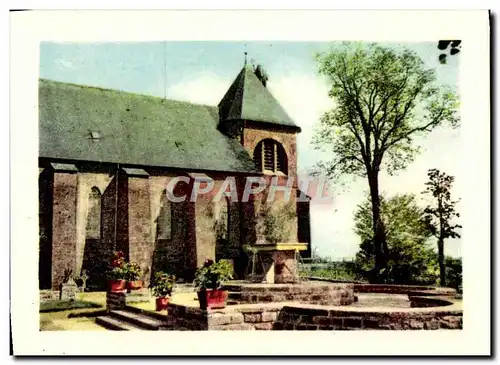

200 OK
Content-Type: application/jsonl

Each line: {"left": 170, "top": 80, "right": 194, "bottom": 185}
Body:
{"left": 160, "top": 303, "right": 462, "bottom": 331}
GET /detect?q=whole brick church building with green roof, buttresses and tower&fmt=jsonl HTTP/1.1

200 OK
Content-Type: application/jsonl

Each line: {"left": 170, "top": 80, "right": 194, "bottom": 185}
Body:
{"left": 39, "top": 64, "right": 310, "bottom": 290}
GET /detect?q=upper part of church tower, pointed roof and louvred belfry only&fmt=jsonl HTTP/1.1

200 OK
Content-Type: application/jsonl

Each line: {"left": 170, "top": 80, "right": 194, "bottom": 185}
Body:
{"left": 219, "top": 62, "right": 300, "bottom": 181}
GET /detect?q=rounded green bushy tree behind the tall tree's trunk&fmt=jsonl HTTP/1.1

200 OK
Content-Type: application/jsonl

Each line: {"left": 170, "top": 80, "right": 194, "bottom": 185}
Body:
{"left": 354, "top": 194, "right": 437, "bottom": 284}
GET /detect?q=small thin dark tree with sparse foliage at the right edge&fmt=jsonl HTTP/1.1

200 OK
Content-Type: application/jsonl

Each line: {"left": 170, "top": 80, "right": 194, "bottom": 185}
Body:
{"left": 423, "top": 169, "right": 462, "bottom": 286}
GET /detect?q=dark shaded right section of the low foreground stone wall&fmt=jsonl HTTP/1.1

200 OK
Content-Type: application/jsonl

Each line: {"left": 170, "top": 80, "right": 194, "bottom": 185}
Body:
{"left": 274, "top": 306, "right": 462, "bottom": 330}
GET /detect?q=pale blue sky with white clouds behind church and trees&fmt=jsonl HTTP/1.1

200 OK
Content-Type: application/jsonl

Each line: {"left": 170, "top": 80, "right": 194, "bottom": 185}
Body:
{"left": 40, "top": 42, "right": 461, "bottom": 260}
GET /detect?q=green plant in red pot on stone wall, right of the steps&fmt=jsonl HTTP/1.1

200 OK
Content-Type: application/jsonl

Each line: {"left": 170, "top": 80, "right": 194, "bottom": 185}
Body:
{"left": 194, "top": 260, "right": 234, "bottom": 309}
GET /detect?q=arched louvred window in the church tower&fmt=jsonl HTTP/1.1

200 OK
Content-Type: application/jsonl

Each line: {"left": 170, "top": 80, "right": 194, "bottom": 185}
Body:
{"left": 253, "top": 138, "right": 288, "bottom": 175}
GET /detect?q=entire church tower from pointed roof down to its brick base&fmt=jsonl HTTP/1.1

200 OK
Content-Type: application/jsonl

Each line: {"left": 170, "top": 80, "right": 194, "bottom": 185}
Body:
{"left": 219, "top": 63, "right": 300, "bottom": 250}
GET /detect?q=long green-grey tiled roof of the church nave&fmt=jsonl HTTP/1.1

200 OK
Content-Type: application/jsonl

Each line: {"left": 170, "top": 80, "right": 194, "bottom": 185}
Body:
{"left": 39, "top": 80, "right": 256, "bottom": 172}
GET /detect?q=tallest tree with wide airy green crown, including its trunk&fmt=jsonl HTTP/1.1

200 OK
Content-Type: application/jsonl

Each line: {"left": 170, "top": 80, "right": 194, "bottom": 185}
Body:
{"left": 313, "top": 43, "right": 458, "bottom": 282}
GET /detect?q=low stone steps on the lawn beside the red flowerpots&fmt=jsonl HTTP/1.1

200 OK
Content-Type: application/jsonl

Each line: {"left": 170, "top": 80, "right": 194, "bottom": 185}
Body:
{"left": 95, "top": 306, "right": 168, "bottom": 331}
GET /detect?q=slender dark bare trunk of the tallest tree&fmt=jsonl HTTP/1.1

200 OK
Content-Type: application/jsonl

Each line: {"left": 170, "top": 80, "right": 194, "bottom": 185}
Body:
{"left": 368, "top": 172, "right": 387, "bottom": 282}
